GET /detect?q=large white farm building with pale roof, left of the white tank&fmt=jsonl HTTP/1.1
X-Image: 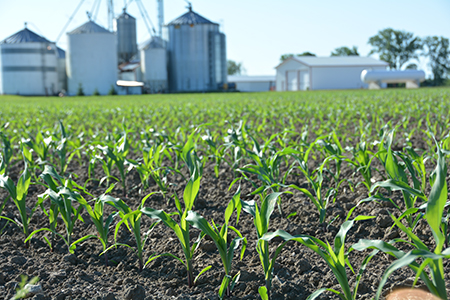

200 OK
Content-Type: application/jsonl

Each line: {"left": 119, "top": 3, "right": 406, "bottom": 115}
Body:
{"left": 276, "top": 56, "right": 389, "bottom": 91}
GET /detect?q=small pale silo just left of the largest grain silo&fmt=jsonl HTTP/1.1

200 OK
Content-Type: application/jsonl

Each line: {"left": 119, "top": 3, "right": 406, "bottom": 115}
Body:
{"left": 140, "top": 37, "right": 168, "bottom": 93}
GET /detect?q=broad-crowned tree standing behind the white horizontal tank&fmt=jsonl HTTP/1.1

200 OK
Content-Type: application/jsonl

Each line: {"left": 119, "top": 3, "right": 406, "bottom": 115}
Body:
{"left": 368, "top": 28, "right": 422, "bottom": 70}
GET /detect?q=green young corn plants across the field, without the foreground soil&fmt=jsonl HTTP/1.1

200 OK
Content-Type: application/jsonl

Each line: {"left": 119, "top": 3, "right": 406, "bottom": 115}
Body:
{"left": 0, "top": 89, "right": 450, "bottom": 299}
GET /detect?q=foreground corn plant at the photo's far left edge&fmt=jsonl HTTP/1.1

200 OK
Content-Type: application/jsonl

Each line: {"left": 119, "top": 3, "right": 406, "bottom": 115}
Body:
{"left": 0, "top": 161, "right": 40, "bottom": 247}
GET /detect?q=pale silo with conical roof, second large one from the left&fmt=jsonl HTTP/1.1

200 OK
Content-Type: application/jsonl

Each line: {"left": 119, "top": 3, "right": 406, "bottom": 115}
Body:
{"left": 66, "top": 21, "right": 118, "bottom": 95}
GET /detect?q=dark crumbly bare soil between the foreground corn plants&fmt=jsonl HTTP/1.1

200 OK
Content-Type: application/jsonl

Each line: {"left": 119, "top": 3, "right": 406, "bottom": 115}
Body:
{"left": 0, "top": 144, "right": 450, "bottom": 300}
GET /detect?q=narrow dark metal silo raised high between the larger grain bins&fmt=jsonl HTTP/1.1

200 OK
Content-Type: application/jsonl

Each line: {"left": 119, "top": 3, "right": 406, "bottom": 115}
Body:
{"left": 115, "top": 9, "right": 138, "bottom": 63}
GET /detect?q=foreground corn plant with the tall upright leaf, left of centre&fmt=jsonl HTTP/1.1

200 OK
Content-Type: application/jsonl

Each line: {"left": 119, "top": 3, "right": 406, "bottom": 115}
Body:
{"left": 141, "top": 146, "right": 206, "bottom": 287}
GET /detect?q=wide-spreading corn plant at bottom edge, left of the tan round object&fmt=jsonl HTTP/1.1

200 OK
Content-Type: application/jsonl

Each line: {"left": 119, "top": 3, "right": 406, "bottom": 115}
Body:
{"left": 260, "top": 215, "right": 378, "bottom": 300}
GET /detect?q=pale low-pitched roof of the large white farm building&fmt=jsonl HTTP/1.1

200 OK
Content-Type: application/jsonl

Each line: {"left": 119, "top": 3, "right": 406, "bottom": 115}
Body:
{"left": 276, "top": 56, "right": 389, "bottom": 68}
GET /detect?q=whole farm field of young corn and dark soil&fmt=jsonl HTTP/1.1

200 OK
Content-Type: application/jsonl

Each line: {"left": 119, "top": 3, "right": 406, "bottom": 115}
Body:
{"left": 0, "top": 89, "right": 450, "bottom": 300}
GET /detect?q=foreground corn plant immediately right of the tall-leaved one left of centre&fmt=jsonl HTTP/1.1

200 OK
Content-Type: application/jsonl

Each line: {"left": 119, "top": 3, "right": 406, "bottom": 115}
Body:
{"left": 186, "top": 190, "right": 247, "bottom": 299}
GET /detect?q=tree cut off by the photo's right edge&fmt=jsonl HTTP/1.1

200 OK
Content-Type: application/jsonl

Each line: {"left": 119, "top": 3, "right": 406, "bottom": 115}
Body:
{"left": 423, "top": 36, "right": 450, "bottom": 86}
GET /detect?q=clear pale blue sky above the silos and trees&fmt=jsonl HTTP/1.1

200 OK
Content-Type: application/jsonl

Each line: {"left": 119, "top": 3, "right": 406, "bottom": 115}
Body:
{"left": 0, "top": 0, "right": 450, "bottom": 75}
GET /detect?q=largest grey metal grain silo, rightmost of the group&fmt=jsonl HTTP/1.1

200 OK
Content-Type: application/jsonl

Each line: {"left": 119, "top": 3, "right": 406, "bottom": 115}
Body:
{"left": 167, "top": 6, "right": 227, "bottom": 92}
